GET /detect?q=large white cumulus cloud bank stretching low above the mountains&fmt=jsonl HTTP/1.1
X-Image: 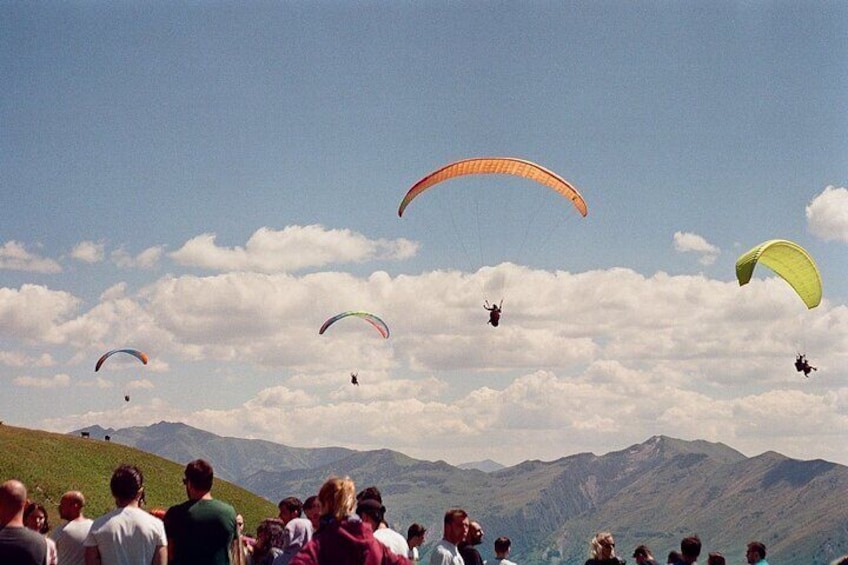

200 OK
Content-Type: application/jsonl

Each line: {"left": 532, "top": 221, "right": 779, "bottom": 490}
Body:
{"left": 16, "top": 263, "right": 848, "bottom": 470}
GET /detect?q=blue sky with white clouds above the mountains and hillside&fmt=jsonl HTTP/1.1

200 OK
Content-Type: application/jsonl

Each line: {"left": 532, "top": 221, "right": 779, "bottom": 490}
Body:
{"left": 0, "top": 2, "right": 848, "bottom": 463}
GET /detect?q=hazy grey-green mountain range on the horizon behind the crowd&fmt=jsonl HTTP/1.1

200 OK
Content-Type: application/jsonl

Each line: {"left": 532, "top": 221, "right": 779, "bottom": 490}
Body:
{"left": 75, "top": 422, "right": 848, "bottom": 565}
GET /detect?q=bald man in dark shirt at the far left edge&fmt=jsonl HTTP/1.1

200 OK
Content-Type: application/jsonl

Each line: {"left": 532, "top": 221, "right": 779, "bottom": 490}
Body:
{"left": 0, "top": 479, "right": 47, "bottom": 565}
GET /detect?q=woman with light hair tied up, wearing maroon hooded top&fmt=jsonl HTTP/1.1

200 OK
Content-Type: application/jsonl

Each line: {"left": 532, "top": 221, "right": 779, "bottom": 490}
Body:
{"left": 291, "top": 477, "right": 409, "bottom": 565}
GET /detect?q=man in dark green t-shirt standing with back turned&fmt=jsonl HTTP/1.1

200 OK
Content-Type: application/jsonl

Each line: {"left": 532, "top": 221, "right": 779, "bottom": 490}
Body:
{"left": 165, "top": 459, "right": 238, "bottom": 565}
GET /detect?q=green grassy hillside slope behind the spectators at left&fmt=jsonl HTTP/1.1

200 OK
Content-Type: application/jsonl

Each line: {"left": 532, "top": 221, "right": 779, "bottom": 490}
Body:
{"left": 0, "top": 425, "right": 277, "bottom": 532}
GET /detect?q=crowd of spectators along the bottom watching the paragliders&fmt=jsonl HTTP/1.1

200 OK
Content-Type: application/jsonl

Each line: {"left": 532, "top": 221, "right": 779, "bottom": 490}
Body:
{"left": 0, "top": 459, "right": 848, "bottom": 565}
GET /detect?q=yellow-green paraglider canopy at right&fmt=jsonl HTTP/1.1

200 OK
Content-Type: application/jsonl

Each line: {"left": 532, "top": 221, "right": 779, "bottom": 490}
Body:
{"left": 736, "top": 239, "right": 822, "bottom": 308}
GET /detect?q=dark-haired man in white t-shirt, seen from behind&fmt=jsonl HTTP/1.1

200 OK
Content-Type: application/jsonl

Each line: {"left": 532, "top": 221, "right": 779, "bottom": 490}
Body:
{"left": 83, "top": 465, "right": 168, "bottom": 565}
